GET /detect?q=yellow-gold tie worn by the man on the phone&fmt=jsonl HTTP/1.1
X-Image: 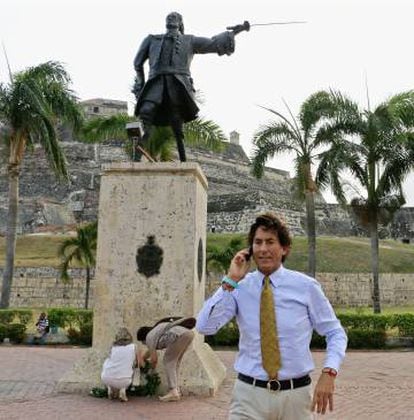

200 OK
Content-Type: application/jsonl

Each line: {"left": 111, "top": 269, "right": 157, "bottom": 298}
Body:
{"left": 260, "top": 276, "right": 281, "bottom": 379}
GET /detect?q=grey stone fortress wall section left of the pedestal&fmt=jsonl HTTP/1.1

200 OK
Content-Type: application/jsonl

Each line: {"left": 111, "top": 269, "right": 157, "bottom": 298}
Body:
{"left": 0, "top": 142, "right": 128, "bottom": 234}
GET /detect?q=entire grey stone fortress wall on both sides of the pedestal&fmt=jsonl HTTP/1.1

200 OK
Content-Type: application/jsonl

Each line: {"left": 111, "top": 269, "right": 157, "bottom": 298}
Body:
{"left": 0, "top": 136, "right": 414, "bottom": 239}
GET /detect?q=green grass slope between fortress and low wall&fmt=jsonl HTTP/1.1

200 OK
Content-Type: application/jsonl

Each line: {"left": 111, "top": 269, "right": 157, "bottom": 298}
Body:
{"left": 0, "top": 233, "right": 414, "bottom": 273}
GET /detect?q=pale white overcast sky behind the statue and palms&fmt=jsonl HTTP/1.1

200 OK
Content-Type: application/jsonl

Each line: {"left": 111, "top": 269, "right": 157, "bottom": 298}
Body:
{"left": 0, "top": 0, "right": 414, "bottom": 206}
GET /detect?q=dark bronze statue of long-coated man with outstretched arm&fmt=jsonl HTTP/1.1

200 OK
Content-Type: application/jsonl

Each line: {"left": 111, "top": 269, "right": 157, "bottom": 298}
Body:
{"left": 133, "top": 12, "right": 249, "bottom": 162}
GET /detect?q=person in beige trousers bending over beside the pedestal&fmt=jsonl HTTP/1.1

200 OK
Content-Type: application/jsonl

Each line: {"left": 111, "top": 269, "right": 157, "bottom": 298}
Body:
{"left": 137, "top": 317, "right": 196, "bottom": 402}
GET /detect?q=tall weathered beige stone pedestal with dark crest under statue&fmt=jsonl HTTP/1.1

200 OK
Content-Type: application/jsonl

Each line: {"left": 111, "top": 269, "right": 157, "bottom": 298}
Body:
{"left": 59, "top": 162, "right": 225, "bottom": 395}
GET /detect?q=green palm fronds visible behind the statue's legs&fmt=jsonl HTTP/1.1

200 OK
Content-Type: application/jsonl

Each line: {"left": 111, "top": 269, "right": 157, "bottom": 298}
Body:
{"left": 81, "top": 114, "right": 230, "bottom": 161}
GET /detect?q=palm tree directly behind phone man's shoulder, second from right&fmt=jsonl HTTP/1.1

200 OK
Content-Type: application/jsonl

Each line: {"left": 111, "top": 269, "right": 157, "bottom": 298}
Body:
{"left": 252, "top": 94, "right": 338, "bottom": 277}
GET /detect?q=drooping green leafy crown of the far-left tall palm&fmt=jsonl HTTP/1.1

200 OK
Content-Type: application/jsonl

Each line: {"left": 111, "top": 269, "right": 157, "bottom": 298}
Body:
{"left": 0, "top": 61, "right": 82, "bottom": 178}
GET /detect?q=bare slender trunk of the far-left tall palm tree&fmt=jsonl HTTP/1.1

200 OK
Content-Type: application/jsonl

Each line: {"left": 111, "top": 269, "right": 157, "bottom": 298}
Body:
{"left": 0, "top": 165, "right": 20, "bottom": 308}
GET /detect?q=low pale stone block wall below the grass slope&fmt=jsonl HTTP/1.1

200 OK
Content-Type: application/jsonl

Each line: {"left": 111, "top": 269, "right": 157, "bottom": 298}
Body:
{"left": 0, "top": 267, "right": 414, "bottom": 308}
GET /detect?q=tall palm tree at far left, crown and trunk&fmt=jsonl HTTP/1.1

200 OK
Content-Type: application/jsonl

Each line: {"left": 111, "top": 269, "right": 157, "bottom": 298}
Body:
{"left": 0, "top": 61, "right": 81, "bottom": 308}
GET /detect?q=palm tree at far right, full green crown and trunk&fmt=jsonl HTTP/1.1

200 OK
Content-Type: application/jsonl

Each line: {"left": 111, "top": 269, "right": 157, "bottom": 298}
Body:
{"left": 317, "top": 91, "right": 414, "bottom": 313}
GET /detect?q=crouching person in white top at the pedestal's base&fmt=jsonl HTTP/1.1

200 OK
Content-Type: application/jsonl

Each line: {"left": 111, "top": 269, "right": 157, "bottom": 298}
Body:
{"left": 101, "top": 327, "right": 142, "bottom": 401}
